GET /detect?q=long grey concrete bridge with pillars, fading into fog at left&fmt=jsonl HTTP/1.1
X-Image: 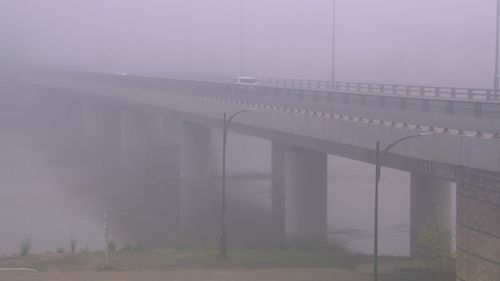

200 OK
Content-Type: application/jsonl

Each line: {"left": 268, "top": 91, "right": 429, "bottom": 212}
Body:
{"left": 19, "top": 72, "right": 500, "bottom": 281}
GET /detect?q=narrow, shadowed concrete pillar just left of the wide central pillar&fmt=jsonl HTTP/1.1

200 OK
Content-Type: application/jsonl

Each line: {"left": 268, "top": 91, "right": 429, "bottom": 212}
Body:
{"left": 271, "top": 142, "right": 286, "bottom": 247}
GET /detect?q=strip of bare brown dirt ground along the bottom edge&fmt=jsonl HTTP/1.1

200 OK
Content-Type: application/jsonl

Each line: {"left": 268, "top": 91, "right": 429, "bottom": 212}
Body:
{"left": 0, "top": 268, "right": 371, "bottom": 281}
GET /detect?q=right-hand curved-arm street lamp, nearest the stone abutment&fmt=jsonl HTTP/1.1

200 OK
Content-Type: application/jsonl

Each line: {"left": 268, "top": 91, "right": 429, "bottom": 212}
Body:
{"left": 373, "top": 132, "right": 432, "bottom": 281}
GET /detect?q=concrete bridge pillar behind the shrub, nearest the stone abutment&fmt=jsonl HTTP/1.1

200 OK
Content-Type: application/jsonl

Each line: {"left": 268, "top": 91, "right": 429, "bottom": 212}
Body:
{"left": 410, "top": 173, "right": 452, "bottom": 256}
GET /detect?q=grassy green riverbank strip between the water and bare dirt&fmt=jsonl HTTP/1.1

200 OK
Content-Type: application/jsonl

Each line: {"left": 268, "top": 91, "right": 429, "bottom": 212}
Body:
{"left": 0, "top": 249, "right": 369, "bottom": 271}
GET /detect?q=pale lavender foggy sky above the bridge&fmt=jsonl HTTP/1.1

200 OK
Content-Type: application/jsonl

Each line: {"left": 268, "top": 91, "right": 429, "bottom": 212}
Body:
{"left": 0, "top": 0, "right": 496, "bottom": 87}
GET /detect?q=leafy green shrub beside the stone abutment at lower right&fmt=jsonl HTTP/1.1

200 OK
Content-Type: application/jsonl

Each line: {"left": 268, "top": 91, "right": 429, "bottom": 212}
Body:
{"left": 413, "top": 216, "right": 456, "bottom": 281}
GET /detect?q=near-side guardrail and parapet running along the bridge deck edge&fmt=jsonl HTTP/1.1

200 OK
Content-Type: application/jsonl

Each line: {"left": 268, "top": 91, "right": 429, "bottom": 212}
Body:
{"left": 32, "top": 70, "right": 500, "bottom": 134}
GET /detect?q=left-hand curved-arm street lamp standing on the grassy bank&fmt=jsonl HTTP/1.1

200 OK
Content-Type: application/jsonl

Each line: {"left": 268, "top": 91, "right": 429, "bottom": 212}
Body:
{"left": 219, "top": 108, "right": 255, "bottom": 258}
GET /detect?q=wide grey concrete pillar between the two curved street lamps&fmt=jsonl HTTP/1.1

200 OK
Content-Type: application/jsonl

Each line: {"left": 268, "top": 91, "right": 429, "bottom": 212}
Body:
{"left": 285, "top": 147, "right": 327, "bottom": 246}
